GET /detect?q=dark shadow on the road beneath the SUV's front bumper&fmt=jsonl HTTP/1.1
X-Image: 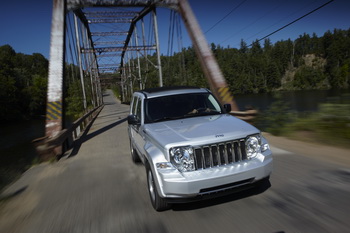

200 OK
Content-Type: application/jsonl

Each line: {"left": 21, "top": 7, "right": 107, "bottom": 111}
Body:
{"left": 172, "top": 179, "right": 271, "bottom": 211}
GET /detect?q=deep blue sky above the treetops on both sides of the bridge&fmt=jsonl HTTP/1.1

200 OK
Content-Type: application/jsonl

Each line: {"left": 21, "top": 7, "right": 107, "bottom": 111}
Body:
{"left": 0, "top": 0, "right": 350, "bottom": 58}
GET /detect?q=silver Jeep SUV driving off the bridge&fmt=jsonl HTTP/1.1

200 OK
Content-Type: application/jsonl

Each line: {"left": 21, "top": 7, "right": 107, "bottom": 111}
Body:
{"left": 128, "top": 87, "right": 272, "bottom": 211}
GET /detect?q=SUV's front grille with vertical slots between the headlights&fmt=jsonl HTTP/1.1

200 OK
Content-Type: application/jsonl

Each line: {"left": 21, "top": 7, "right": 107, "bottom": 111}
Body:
{"left": 194, "top": 139, "right": 247, "bottom": 169}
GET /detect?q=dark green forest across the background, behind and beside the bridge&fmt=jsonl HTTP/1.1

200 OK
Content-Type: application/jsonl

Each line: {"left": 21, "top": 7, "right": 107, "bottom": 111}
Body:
{"left": 0, "top": 29, "right": 350, "bottom": 122}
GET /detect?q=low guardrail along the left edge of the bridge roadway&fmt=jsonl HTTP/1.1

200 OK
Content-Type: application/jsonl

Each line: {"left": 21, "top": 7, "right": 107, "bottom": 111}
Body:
{"left": 32, "top": 105, "right": 104, "bottom": 161}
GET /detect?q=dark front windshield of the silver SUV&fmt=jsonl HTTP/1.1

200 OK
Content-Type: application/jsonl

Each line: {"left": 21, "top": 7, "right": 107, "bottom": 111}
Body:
{"left": 145, "top": 93, "right": 222, "bottom": 123}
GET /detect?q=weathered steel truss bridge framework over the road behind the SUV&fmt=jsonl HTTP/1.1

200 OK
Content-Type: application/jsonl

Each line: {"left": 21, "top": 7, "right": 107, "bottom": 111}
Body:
{"left": 40, "top": 0, "right": 243, "bottom": 157}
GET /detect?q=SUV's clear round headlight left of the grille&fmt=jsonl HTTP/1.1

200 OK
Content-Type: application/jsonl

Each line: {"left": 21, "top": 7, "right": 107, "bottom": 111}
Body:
{"left": 169, "top": 146, "right": 195, "bottom": 172}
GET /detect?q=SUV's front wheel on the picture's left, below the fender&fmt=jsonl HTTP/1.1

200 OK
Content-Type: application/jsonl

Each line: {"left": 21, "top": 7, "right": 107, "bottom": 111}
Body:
{"left": 146, "top": 163, "right": 170, "bottom": 211}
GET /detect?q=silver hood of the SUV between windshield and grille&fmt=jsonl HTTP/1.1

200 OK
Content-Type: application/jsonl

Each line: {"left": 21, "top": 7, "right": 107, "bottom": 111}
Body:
{"left": 145, "top": 114, "right": 260, "bottom": 148}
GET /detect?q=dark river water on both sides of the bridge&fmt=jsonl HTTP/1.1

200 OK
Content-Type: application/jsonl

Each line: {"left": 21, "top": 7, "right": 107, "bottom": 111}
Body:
{"left": 0, "top": 89, "right": 350, "bottom": 190}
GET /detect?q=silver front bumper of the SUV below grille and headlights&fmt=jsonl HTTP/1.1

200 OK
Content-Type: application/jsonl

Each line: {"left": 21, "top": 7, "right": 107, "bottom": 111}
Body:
{"left": 157, "top": 153, "right": 273, "bottom": 199}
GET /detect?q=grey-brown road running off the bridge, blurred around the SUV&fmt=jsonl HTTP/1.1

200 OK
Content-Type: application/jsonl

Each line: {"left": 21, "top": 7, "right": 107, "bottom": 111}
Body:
{"left": 0, "top": 91, "right": 350, "bottom": 233}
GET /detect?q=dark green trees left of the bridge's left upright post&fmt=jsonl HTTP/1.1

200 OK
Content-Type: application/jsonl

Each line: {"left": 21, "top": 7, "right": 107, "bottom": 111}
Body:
{"left": 0, "top": 45, "right": 48, "bottom": 120}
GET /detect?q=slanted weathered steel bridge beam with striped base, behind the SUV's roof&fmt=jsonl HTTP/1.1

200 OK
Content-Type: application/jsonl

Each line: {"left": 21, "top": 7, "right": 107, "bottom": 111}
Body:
{"left": 178, "top": 0, "right": 238, "bottom": 111}
